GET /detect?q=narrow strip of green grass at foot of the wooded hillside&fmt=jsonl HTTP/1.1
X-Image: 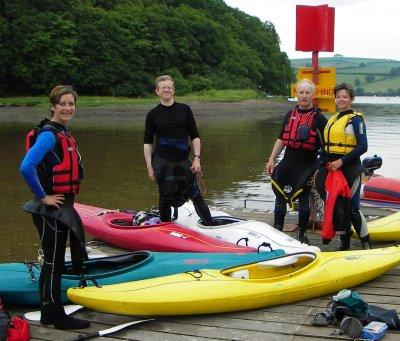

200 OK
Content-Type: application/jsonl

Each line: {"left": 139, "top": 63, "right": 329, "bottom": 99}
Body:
{"left": 0, "top": 89, "right": 286, "bottom": 108}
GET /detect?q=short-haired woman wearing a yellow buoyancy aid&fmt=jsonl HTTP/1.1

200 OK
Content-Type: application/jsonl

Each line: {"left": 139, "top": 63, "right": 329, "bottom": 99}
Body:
{"left": 324, "top": 83, "right": 371, "bottom": 250}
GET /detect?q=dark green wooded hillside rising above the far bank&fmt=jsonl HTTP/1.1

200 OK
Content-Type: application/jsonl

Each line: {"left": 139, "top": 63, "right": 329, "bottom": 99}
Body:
{"left": 0, "top": 0, "right": 294, "bottom": 96}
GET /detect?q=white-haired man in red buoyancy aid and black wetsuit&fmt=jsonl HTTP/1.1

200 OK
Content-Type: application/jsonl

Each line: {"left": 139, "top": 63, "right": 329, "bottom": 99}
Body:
{"left": 265, "top": 79, "right": 327, "bottom": 244}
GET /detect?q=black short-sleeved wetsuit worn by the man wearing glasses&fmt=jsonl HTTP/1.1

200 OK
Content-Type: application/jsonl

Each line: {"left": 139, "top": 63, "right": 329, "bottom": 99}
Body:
{"left": 143, "top": 102, "right": 212, "bottom": 225}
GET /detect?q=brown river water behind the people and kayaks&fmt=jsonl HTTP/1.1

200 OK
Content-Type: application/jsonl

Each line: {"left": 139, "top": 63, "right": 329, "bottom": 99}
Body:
{"left": 0, "top": 98, "right": 400, "bottom": 262}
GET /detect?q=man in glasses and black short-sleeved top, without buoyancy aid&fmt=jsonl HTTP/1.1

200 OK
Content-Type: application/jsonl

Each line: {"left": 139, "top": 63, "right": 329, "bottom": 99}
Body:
{"left": 143, "top": 75, "right": 213, "bottom": 225}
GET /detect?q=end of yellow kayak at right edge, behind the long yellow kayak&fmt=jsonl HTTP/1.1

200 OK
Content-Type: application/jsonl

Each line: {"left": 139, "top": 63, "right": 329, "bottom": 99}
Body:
{"left": 362, "top": 212, "right": 400, "bottom": 242}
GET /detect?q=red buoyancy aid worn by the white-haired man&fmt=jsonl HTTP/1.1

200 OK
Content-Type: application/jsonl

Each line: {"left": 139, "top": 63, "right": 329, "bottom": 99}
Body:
{"left": 282, "top": 108, "right": 317, "bottom": 151}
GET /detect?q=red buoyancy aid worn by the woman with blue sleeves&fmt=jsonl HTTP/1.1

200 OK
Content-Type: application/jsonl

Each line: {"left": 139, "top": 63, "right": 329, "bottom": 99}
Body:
{"left": 25, "top": 124, "right": 83, "bottom": 194}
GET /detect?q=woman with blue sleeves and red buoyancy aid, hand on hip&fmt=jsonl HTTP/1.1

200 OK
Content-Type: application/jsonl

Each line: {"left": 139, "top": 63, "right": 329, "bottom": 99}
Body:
{"left": 20, "top": 85, "right": 90, "bottom": 329}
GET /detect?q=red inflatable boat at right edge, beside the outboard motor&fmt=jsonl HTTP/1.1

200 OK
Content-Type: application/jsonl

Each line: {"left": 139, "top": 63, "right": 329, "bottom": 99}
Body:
{"left": 362, "top": 176, "right": 400, "bottom": 203}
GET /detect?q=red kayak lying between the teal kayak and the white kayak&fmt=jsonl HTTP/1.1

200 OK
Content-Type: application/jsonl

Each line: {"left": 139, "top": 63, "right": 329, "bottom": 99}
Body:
{"left": 75, "top": 203, "right": 257, "bottom": 253}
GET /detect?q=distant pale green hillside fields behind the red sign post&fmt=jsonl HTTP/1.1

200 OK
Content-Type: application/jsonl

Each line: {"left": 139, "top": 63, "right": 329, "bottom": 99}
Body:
{"left": 291, "top": 57, "right": 400, "bottom": 96}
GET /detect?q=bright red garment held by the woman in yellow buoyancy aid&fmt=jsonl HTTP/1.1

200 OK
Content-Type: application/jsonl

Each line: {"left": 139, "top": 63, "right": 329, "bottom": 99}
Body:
{"left": 321, "top": 169, "right": 351, "bottom": 240}
